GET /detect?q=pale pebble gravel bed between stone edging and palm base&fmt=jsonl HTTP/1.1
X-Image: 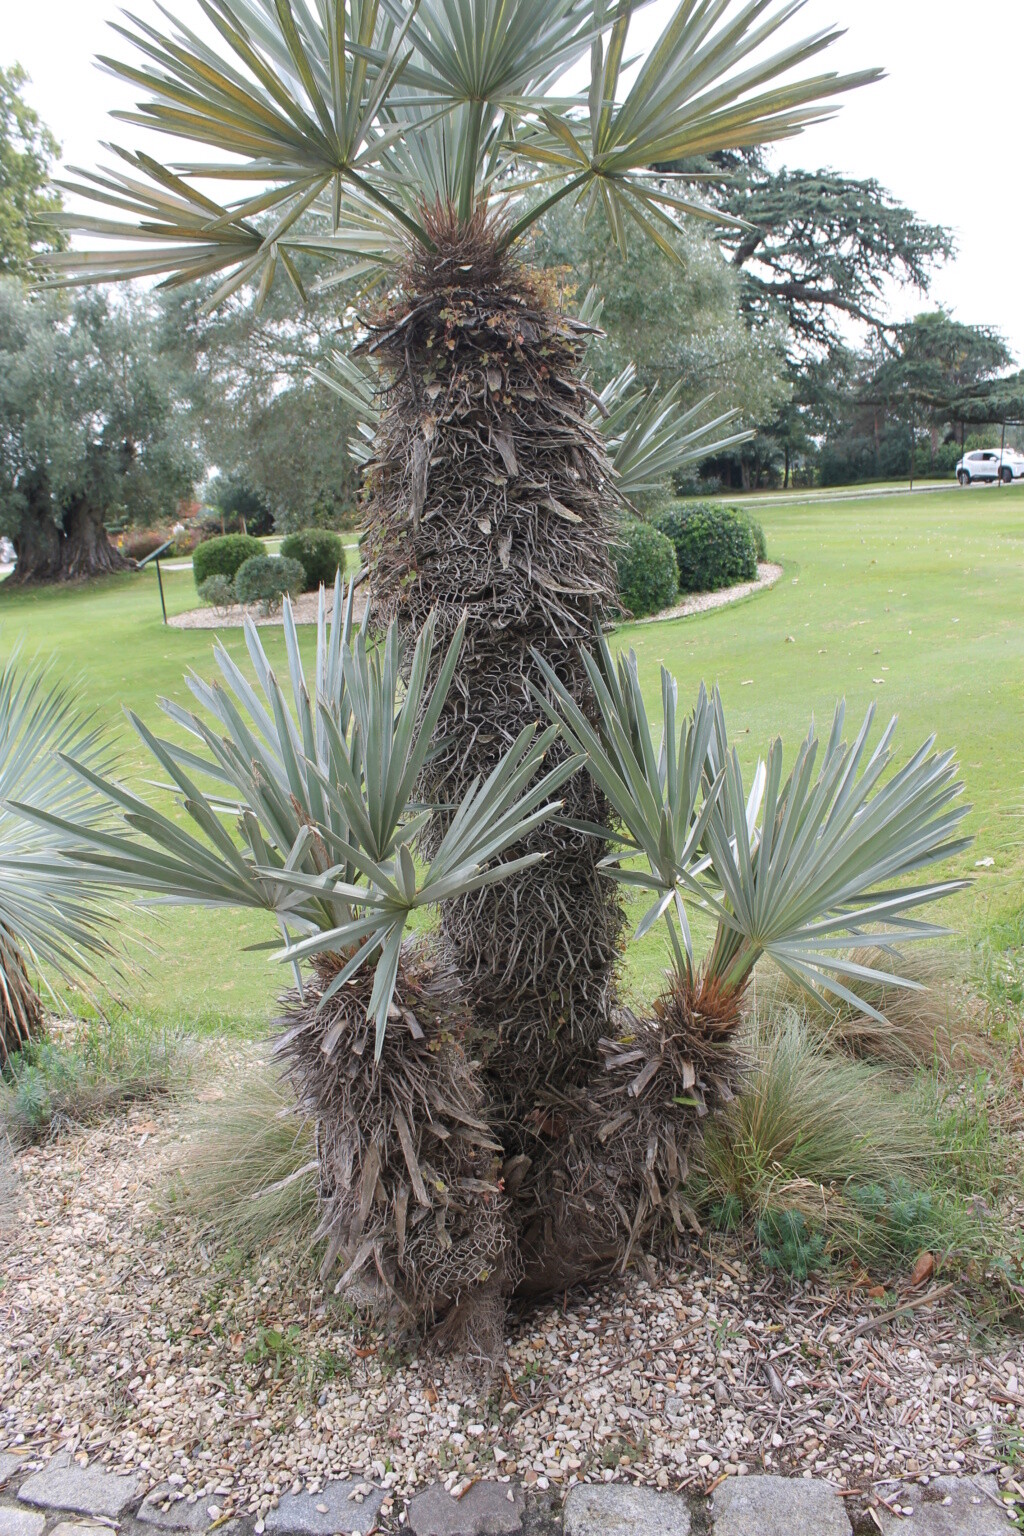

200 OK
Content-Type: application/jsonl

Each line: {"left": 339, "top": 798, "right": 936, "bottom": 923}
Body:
{"left": 0, "top": 1106, "right": 1024, "bottom": 1533}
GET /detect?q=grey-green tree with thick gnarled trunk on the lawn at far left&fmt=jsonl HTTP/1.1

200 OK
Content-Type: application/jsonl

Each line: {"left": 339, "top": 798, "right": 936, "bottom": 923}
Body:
{"left": 0, "top": 280, "right": 200, "bottom": 584}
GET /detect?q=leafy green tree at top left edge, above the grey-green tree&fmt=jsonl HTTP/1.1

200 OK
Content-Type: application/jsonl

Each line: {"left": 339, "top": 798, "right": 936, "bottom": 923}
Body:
{"left": 0, "top": 65, "right": 68, "bottom": 276}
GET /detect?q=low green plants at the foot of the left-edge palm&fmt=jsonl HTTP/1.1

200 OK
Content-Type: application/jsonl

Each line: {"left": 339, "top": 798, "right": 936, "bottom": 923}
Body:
{"left": 0, "top": 1018, "right": 192, "bottom": 1146}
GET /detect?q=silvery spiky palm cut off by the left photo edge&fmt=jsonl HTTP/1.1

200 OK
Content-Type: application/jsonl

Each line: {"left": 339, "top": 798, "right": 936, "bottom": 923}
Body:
{"left": 0, "top": 654, "right": 114, "bottom": 1066}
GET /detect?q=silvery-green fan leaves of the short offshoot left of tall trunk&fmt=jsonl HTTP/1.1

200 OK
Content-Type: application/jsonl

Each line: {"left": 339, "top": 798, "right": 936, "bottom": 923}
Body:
{"left": 47, "top": 576, "right": 579, "bottom": 1058}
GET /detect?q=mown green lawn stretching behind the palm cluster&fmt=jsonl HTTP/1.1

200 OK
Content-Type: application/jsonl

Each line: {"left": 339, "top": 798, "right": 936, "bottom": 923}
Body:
{"left": 0, "top": 487, "right": 1024, "bottom": 1032}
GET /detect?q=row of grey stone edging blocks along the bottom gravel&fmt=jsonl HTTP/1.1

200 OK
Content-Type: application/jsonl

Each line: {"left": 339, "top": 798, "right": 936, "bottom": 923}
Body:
{"left": 0, "top": 1452, "right": 1012, "bottom": 1536}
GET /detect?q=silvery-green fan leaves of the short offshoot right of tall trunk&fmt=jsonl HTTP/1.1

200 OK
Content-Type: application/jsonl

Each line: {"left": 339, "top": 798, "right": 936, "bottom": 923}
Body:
{"left": 537, "top": 628, "right": 967, "bottom": 1021}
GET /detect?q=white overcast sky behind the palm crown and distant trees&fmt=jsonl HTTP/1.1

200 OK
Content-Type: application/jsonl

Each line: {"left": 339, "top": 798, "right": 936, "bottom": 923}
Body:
{"left": 8, "top": 0, "right": 1024, "bottom": 364}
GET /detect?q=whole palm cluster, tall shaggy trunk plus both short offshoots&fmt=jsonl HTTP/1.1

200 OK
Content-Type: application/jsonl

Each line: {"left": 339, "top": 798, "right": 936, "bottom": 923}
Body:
{"left": 40, "top": 0, "right": 976, "bottom": 1358}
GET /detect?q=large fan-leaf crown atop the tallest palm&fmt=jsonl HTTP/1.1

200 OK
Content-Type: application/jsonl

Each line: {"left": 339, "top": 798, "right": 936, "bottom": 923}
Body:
{"left": 51, "top": 0, "right": 877, "bottom": 296}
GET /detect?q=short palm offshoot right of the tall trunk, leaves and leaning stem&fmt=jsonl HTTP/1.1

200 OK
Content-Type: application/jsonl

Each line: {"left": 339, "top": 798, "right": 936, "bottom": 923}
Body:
{"left": 537, "top": 633, "right": 970, "bottom": 1290}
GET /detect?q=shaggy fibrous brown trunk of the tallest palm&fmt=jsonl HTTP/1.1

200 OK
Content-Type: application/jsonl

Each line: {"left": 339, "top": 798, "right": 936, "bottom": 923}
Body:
{"left": 367, "top": 223, "right": 622, "bottom": 1290}
